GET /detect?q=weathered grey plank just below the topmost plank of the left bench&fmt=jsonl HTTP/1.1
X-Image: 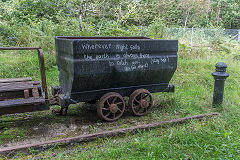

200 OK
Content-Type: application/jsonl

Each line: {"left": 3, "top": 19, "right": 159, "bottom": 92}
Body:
{"left": 0, "top": 81, "right": 33, "bottom": 92}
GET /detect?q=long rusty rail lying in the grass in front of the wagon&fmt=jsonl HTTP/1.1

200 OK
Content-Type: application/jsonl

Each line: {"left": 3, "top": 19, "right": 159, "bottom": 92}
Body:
{"left": 0, "top": 112, "right": 220, "bottom": 155}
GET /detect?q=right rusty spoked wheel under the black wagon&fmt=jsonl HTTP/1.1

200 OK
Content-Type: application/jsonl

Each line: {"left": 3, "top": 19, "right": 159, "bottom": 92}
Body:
{"left": 128, "top": 89, "right": 153, "bottom": 116}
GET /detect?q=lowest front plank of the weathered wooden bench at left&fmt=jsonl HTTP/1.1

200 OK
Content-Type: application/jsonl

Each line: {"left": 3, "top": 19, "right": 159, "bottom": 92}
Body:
{"left": 0, "top": 97, "right": 45, "bottom": 108}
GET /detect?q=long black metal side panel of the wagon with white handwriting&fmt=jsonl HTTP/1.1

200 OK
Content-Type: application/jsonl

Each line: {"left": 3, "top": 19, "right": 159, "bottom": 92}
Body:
{"left": 72, "top": 40, "right": 178, "bottom": 93}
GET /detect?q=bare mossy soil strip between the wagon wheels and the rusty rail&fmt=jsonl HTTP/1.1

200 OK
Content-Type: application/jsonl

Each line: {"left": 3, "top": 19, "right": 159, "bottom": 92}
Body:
{"left": 0, "top": 103, "right": 173, "bottom": 149}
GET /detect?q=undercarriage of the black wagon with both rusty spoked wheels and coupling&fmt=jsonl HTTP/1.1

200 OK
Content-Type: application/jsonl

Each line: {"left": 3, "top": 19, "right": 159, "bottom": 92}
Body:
{"left": 53, "top": 84, "right": 174, "bottom": 121}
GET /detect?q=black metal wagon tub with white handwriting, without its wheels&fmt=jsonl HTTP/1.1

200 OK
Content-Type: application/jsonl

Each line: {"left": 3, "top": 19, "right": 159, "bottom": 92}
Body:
{"left": 55, "top": 37, "right": 178, "bottom": 120}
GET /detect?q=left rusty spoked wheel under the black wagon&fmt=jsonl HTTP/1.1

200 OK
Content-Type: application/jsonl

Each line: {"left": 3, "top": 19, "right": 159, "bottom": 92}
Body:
{"left": 97, "top": 92, "right": 125, "bottom": 121}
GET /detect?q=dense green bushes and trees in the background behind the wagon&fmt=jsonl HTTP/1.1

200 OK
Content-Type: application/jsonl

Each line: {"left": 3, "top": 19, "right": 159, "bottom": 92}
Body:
{"left": 0, "top": 0, "right": 240, "bottom": 48}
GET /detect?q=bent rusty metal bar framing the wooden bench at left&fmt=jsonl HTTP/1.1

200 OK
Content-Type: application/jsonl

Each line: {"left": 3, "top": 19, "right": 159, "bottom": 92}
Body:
{"left": 0, "top": 47, "right": 49, "bottom": 104}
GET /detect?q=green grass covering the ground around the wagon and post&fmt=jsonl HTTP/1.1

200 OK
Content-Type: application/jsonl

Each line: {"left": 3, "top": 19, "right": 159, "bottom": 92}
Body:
{"left": 0, "top": 38, "right": 240, "bottom": 159}
